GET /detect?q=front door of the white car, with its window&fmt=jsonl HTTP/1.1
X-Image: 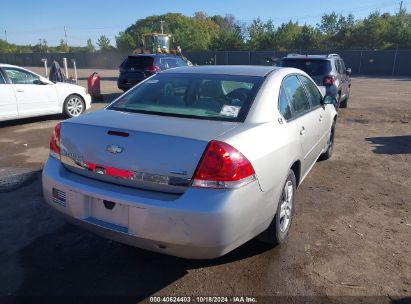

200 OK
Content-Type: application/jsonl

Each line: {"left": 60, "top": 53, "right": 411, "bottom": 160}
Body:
{"left": 3, "top": 67, "right": 58, "bottom": 117}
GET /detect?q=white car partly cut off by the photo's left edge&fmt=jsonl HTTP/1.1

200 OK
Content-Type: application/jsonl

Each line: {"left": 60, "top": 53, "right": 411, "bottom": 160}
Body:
{"left": 0, "top": 64, "right": 91, "bottom": 121}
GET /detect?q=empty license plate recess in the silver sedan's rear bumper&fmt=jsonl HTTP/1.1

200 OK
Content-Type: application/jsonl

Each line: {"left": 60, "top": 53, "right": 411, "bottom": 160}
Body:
{"left": 90, "top": 198, "right": 129, "bottom": 229}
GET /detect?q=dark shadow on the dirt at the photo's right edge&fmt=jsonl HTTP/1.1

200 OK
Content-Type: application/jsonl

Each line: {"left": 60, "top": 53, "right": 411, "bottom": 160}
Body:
{"left": 365, "top": 135, "right": 411, "bottom": 155}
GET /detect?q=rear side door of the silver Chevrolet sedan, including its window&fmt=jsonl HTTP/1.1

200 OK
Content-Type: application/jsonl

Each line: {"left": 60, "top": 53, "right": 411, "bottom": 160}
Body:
{"left": 283, "top": 75, "right": 319, "bottom": 176}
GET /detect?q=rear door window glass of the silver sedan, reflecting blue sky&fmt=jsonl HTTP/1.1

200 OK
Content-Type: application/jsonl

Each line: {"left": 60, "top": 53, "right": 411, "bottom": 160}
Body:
{"left": 283, "top": 76, "right": 310, "bottom": 116}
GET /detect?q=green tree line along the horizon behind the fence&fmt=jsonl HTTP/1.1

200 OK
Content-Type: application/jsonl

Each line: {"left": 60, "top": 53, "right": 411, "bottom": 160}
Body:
{"left": 0, "top": 9, "right": 411, "bottom": 53}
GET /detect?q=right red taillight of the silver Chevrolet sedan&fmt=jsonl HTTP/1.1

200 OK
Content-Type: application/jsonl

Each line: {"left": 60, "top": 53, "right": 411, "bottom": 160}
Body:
{"left": 192, "top": 140, "right": 256, "bottom": 189}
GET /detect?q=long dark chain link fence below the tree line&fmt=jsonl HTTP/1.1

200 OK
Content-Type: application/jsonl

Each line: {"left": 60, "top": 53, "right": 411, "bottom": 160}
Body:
{"left": 0, "top": 50, "right": 411, "bottom": 76}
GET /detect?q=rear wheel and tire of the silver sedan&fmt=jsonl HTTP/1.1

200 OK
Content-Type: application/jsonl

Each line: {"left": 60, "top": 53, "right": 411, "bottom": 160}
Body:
{"left": 258, "top": 170, "right": 297, "bottom": 245}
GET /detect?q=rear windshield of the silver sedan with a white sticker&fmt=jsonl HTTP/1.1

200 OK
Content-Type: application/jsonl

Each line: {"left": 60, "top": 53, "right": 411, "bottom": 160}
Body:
{"left": 108, "top": 73, "right": 264, "bottom": 121}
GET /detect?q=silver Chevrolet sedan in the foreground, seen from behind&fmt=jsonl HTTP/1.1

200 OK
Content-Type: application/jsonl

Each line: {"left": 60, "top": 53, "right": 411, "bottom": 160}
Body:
{"left": 43, "top": 66, "right": 337, "bottom": 258}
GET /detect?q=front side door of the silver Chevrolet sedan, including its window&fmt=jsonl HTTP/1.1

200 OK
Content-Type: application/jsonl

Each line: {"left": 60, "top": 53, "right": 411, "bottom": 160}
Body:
{"left": 298, "top": 75, "right": 331, "bottom": 151}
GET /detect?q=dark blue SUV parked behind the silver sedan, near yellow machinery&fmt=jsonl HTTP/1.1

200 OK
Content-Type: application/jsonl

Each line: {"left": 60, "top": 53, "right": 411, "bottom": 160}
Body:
{"left": 117, "top": 54, "right": 189, "bottom": 92}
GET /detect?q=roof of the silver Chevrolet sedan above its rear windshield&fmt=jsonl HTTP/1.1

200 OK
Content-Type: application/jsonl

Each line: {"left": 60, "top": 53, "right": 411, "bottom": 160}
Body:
{"left": 161, "top": 65, "right": 280, "bottom": 77}
